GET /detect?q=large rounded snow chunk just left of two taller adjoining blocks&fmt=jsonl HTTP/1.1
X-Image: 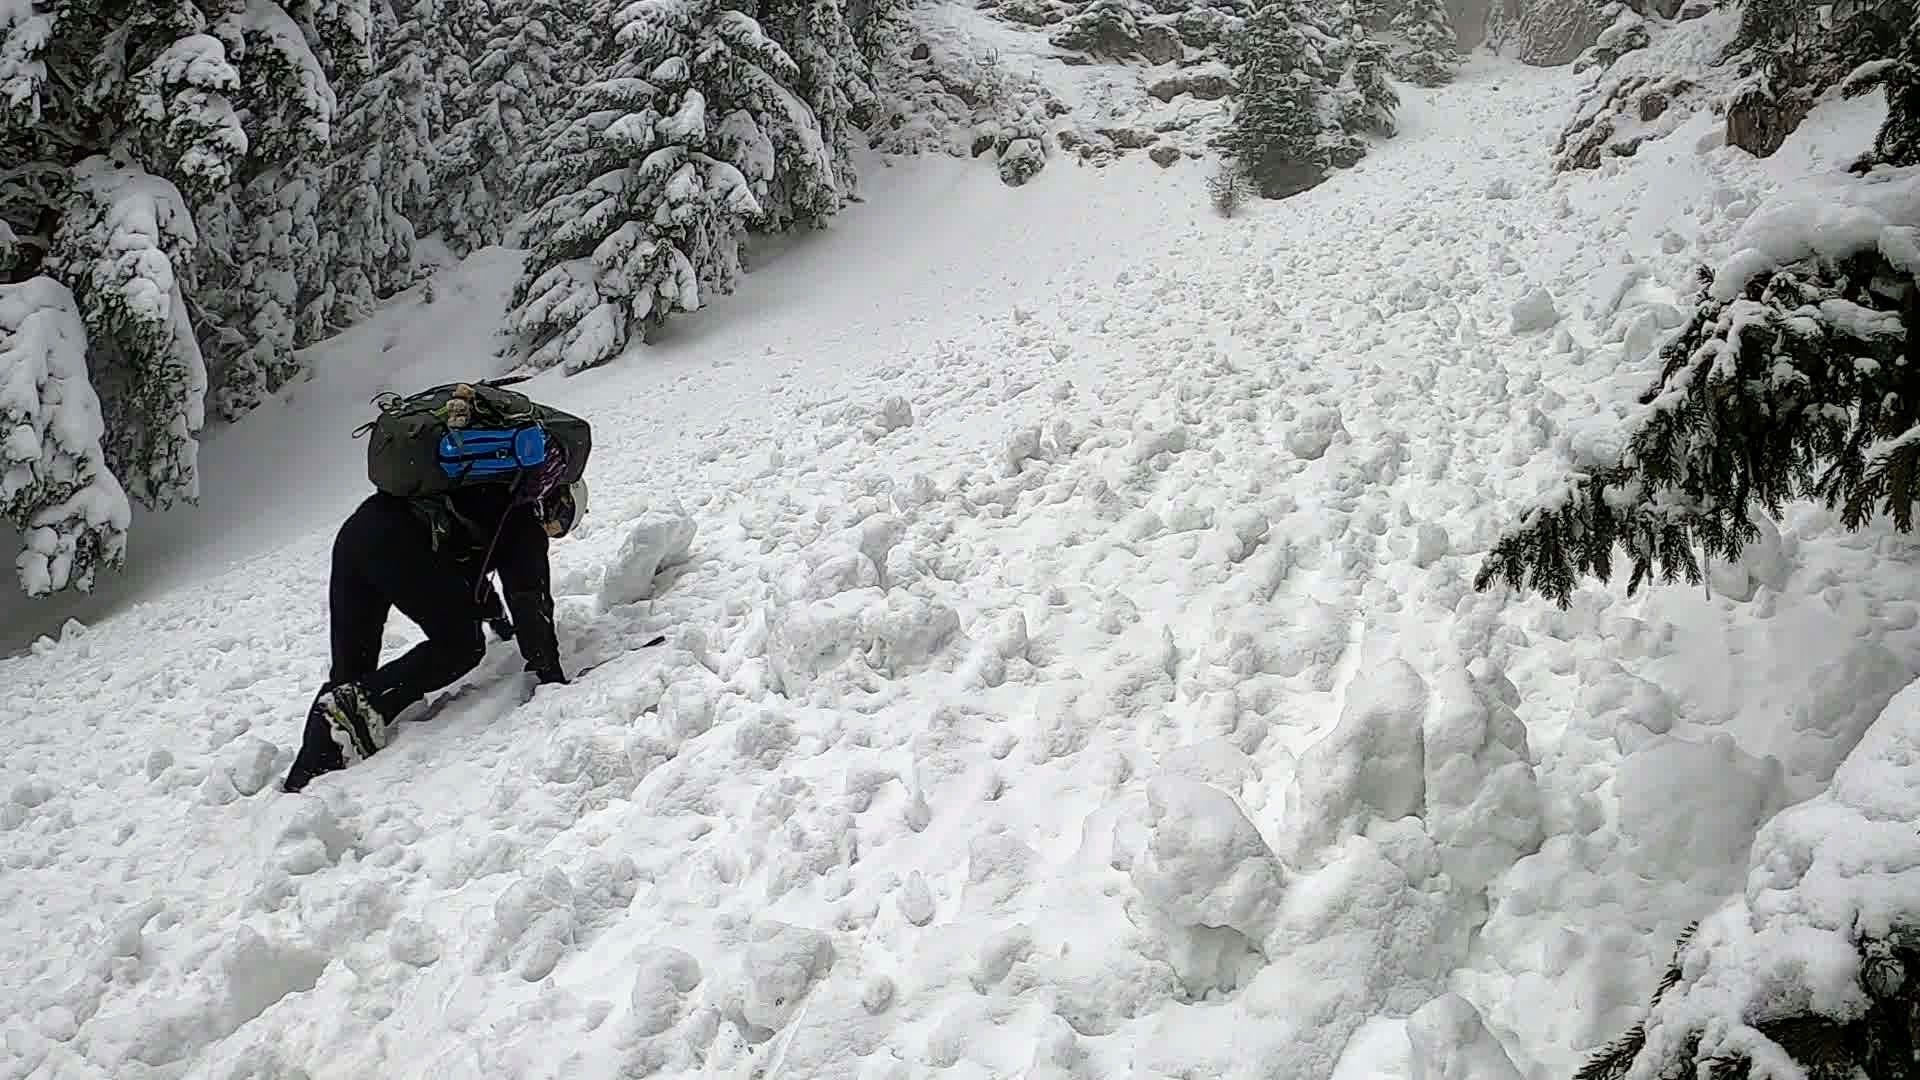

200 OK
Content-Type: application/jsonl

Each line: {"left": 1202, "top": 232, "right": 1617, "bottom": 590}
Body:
{"left": 1131, "top": 776, "right": 1286, "bottom": 942}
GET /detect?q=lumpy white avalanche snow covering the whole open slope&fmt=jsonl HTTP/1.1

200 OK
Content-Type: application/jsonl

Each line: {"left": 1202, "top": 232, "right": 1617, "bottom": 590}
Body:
{"left": 0, "top": 37, "right": 1920, "bottom": 1080}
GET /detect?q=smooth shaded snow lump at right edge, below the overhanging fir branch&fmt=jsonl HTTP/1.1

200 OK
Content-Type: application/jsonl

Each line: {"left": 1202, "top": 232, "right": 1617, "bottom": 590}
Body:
{"left": 1782, "top": 642, "right": 1920, "bottom": 782}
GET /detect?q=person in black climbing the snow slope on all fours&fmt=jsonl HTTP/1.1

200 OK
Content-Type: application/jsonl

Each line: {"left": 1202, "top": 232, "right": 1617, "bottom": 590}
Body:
{"left": 280, "top": 384, "right": 589, "bottom": 792}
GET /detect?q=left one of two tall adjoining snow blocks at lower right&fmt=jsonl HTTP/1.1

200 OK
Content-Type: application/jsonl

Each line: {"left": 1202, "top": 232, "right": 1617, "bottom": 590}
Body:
{"left": 1286, "top": 657, "right": 1427, "bottom": 865}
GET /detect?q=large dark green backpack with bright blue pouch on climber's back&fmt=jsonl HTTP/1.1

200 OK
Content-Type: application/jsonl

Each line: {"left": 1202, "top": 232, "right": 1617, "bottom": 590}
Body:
{"left": 353, "top": 377, "right": 593, "bottom": 498}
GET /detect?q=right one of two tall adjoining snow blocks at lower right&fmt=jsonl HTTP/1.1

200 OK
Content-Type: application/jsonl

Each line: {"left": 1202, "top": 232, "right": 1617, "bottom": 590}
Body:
{"left": 1423, "top": 667, "right": 1544, "bottom": 890}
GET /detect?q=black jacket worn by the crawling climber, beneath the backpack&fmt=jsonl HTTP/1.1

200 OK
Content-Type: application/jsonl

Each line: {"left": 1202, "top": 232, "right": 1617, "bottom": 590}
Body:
{"left": 430, "top": 484, "right": 561, "bottom": 673}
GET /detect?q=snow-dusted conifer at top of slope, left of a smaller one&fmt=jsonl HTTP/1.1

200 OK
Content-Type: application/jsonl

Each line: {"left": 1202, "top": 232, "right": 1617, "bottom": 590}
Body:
{"left": 1221, "top": 0, "right": 1329, "bottom": 198}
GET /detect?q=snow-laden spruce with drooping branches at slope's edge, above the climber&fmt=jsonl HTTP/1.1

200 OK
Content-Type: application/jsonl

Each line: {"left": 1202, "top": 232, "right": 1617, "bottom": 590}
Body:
{"left": 509, "top": 0, "right": 817, "bottom": 371}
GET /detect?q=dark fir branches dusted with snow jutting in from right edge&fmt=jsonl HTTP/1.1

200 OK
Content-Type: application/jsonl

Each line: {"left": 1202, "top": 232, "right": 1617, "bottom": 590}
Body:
{"left": 1475, "top": 4, "right": 1920, "bottom": 607}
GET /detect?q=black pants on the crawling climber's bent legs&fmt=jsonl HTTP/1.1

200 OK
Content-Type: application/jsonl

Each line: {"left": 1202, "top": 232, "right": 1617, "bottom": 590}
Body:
{"left": 286, "top": 494, "right": 497, "bottom": 790}
